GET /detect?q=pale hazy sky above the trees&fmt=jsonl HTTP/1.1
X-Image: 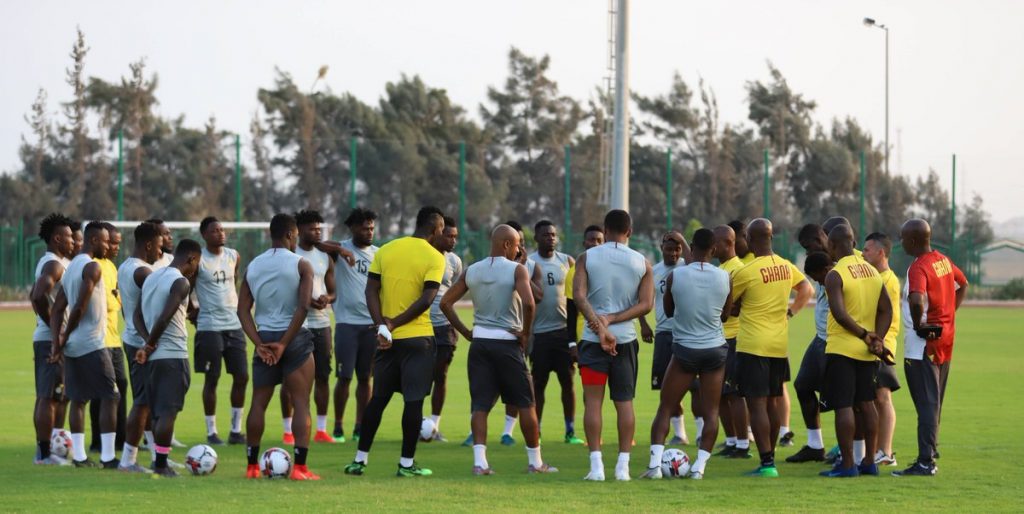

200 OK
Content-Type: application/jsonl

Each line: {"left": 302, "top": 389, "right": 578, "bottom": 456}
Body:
{"left": 0, "top": 0, "right": 1024, "bottom": 221}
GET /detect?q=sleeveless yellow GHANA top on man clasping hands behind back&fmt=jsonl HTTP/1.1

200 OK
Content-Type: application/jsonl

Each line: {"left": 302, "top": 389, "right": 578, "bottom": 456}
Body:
{"left": 825, "top": 255, "right": 883, "bottom": 360}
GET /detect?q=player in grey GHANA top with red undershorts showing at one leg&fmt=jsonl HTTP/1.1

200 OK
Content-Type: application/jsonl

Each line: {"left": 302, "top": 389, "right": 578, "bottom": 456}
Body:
{"left": 572, "top": 210, "right": 654, "bottom": 481}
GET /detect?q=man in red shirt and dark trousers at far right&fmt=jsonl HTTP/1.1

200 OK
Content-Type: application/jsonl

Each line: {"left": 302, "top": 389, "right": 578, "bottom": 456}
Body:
{"left": 893, "top": 219, "right": 968, "bottom": 476}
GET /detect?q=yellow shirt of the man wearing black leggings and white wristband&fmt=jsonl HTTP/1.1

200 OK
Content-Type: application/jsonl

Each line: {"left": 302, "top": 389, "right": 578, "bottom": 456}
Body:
{"left": 370, "top": 237, "right": 444, "bottom": 339}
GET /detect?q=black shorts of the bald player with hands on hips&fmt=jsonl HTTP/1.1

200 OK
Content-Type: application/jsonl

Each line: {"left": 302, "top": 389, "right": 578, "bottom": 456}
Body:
{"left": 466, "top": 338, "right": 534, "bottom": 413}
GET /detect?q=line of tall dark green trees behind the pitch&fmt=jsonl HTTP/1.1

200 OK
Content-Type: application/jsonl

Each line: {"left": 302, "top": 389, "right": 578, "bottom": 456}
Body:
{"left": 0, "top": 31, "right": 992, "bottom": 245}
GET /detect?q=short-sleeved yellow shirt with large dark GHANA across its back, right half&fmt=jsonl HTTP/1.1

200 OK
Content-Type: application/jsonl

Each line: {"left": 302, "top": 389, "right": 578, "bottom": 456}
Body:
{"left": 732, "top": 254, "right": 804, "bottom": 357}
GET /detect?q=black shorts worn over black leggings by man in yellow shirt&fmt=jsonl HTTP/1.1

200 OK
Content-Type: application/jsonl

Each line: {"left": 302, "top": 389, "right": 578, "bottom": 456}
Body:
{"left": 374, "top": 337, "right": 435, "bottom": 401}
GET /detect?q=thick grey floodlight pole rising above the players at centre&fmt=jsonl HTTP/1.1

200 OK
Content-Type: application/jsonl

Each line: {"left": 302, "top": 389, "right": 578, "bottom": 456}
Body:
{"left": 609, "top": 0, "right": 630, "bottom": 211}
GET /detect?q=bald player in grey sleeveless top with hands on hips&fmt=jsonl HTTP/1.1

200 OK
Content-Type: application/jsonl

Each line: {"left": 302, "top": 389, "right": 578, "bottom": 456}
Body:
{"left": 441, "top": 225, "right": 558, "bottom": 475}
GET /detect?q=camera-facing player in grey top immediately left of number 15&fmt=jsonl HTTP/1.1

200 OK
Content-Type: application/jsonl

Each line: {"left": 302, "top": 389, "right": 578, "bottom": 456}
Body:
{"left": 281, "top": 211, "right": 336, "bottom": 442}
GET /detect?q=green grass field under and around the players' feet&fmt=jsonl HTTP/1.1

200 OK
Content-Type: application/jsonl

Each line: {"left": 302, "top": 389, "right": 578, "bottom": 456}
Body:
{"left": 0, "top": 308, "right": 1024, "bottom": 512}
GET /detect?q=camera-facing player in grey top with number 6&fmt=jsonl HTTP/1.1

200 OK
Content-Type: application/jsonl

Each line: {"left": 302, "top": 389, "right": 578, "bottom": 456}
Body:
{"left": 529, "top": 219, "right": 583, "bottom": 444}
